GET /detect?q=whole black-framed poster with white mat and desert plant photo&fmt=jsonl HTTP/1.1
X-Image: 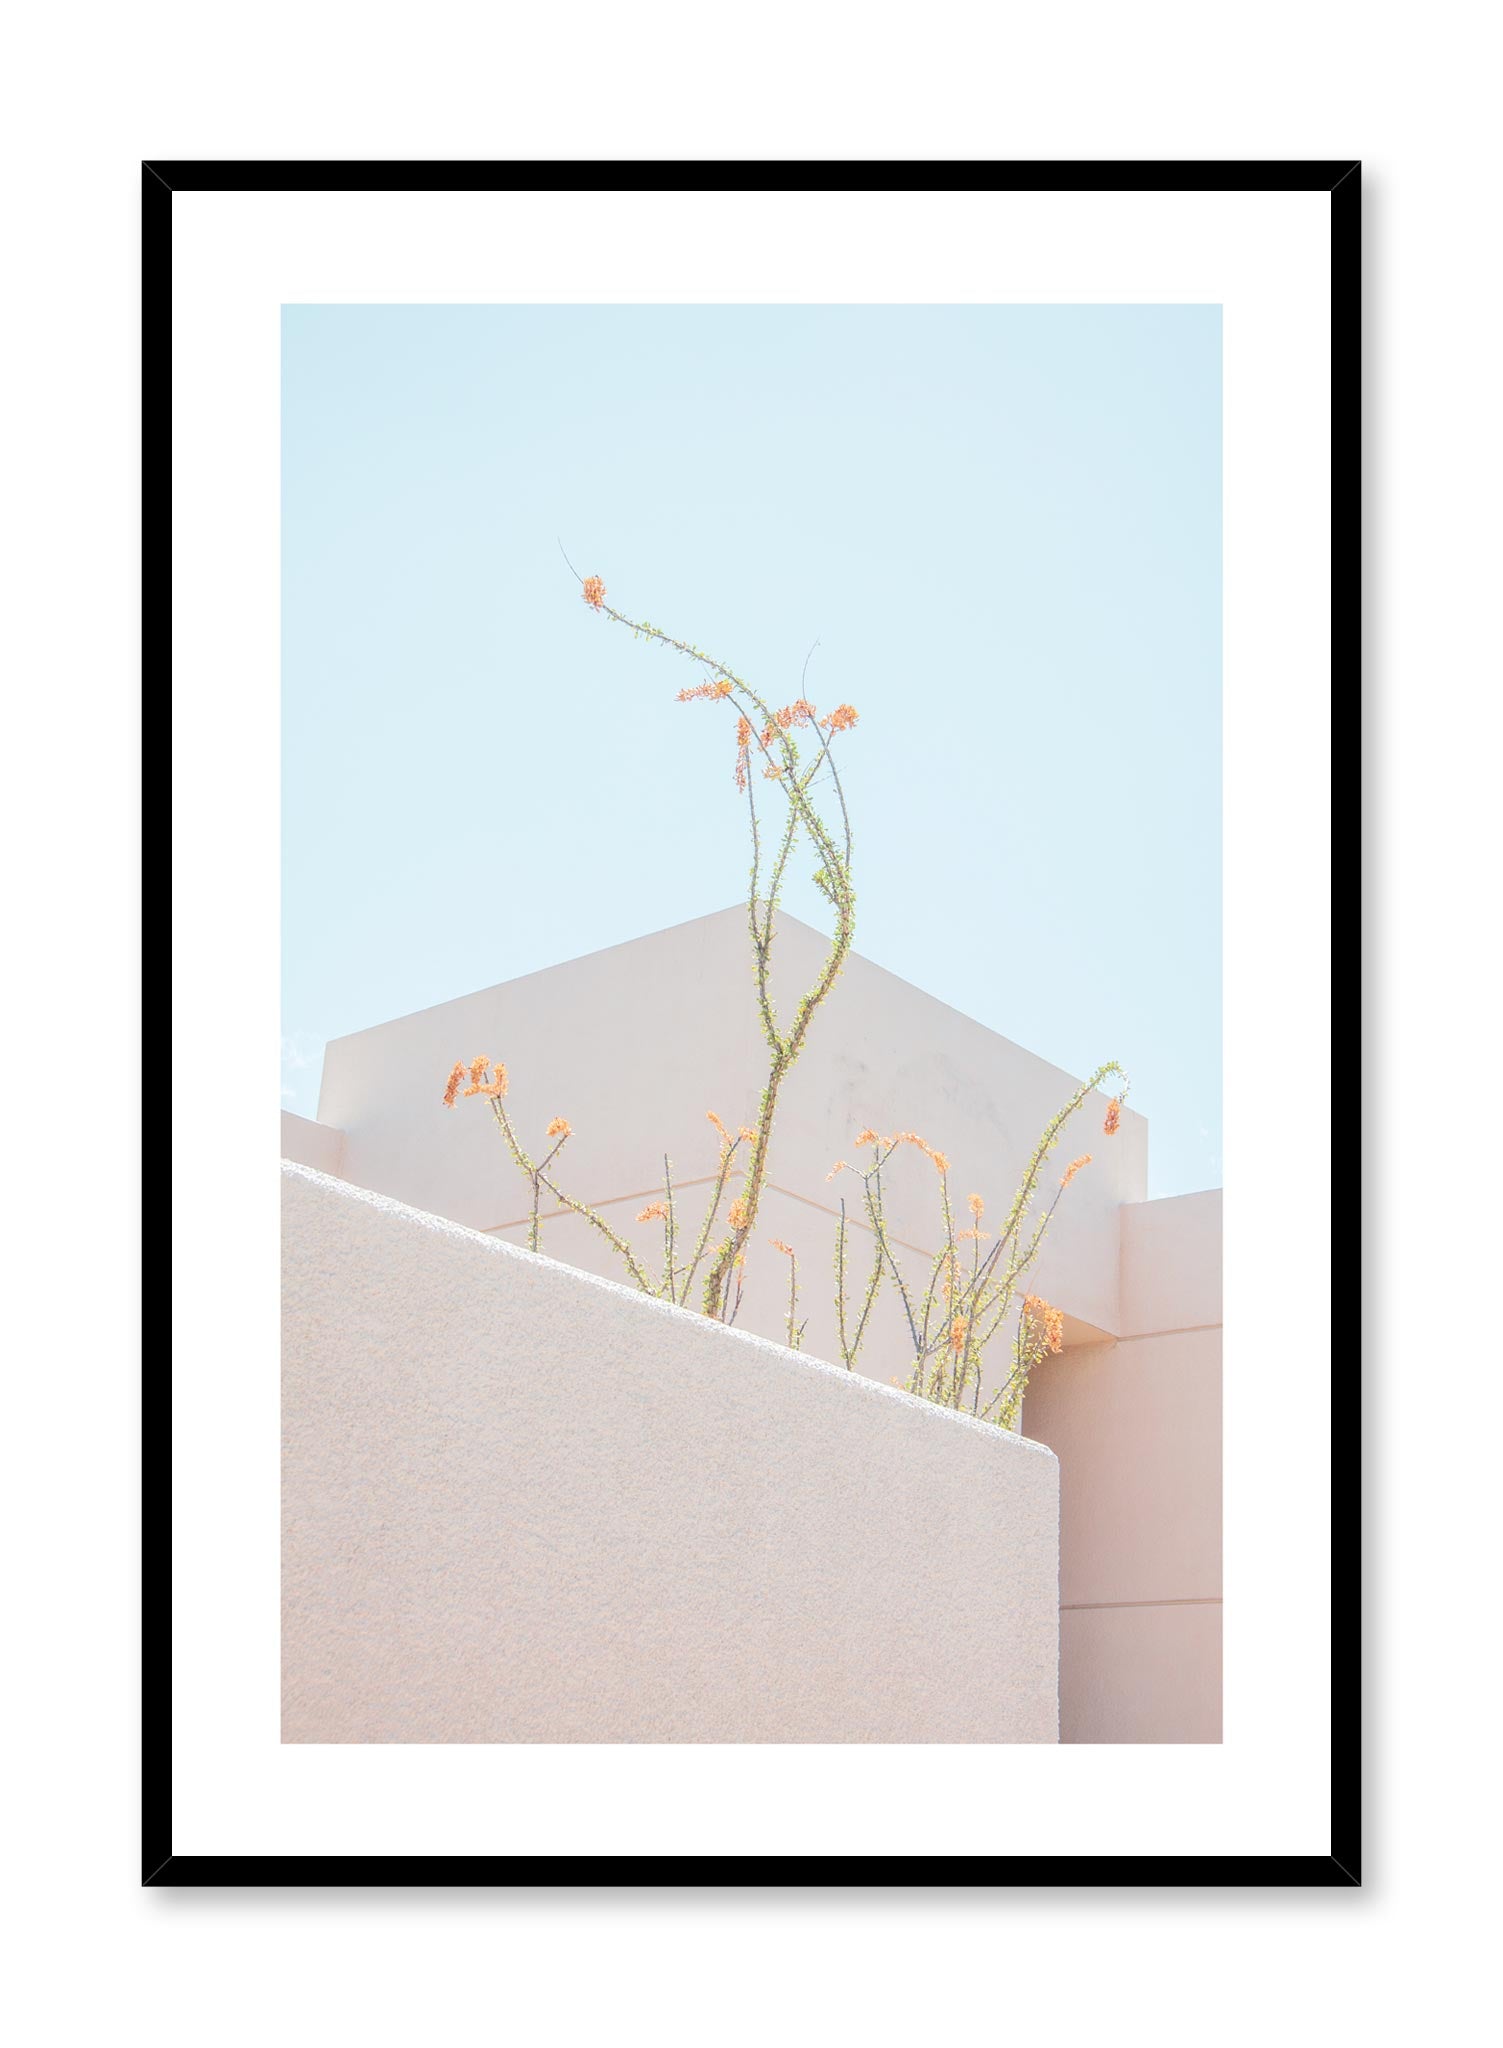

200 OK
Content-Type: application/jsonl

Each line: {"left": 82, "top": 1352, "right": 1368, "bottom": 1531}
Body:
{"left": 143, "top": 162, "right": 1360, "bottom": 1886}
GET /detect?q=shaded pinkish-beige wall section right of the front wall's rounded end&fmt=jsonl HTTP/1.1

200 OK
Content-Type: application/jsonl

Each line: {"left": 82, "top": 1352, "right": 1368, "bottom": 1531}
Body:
{"left": 1022, "top": 1192, "right": 1222, "bottom": 1743}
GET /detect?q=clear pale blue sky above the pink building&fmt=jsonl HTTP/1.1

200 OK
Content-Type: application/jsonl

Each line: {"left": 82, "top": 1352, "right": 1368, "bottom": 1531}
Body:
{"left": 283, "top": 305, "right": 1220, "bottom": 1194}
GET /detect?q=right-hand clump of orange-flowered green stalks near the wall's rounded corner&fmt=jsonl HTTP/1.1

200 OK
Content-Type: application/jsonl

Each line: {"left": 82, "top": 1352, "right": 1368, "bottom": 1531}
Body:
{"left": 827, "top": 1061, "right": 1126, "bottom": 1430}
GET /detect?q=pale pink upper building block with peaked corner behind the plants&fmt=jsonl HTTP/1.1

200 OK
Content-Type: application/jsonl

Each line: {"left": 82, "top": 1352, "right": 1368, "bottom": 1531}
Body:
{"left": 319, "top": 905, "right": 1147, "bottom": 1339}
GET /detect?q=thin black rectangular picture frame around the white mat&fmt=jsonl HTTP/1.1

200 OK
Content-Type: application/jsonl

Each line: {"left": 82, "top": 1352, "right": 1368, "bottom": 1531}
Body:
{"left": 141, "top": 160, "right": 1362, "bottom": 1888}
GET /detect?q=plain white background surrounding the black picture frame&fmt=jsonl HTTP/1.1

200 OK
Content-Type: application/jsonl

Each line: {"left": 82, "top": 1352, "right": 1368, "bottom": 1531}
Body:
{"left": 0, "top": 12, "right": 1503, "bottom": 2048}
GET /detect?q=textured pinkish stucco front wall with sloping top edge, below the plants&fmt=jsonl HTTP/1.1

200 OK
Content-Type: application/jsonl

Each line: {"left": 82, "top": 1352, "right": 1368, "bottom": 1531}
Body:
{"left": 283, "top": 1171, "right": 1059, "bottom": 1743}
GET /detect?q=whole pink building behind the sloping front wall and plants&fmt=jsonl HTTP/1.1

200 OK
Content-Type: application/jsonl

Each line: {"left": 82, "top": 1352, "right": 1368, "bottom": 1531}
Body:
{"left": 283, "top": 907, "right": 1222, "bottom": 1743}
